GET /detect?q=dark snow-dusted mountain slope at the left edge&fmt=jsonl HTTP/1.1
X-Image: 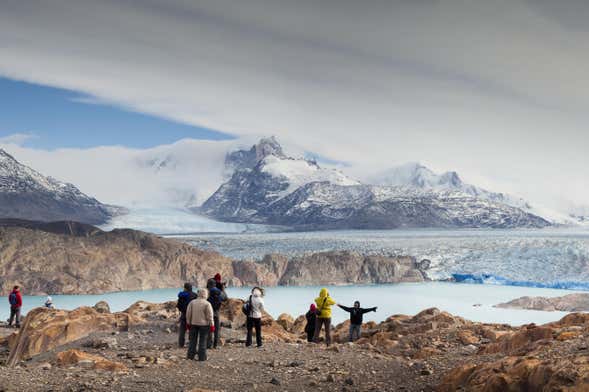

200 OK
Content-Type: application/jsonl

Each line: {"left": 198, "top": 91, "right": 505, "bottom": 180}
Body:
{"left": 0, "top": 149, "right": 122, "bottom": 224}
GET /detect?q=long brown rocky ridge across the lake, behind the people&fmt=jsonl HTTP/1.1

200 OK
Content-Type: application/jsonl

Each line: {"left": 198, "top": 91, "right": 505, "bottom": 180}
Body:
{"left": 0, "top": 220, "right": 428, "bottom": 295}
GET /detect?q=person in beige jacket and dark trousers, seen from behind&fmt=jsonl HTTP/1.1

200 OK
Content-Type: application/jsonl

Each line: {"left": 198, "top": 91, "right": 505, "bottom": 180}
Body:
{"left": 186, "top": 289, "right": 215, "bottom": 361}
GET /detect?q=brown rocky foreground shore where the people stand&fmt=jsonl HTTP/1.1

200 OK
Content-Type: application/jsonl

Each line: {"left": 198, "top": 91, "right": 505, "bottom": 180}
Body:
{"left": 0, "top": 300, "right": 589, "bottom": 392}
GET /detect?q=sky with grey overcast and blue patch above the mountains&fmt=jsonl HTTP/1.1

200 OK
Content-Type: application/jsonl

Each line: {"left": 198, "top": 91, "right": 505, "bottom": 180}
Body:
{"left": 0, "top": 0, "right": 589, "bottom": 214}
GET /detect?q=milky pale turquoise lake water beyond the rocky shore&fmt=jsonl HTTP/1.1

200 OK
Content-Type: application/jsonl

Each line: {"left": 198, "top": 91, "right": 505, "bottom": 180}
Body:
{"left": 5, "top": 282, "right": 571, "bottom": 325}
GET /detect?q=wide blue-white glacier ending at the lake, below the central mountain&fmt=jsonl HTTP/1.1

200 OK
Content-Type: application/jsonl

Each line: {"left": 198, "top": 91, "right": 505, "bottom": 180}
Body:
{"left": 184, "top": 228, "right": 589, "bottom": 290}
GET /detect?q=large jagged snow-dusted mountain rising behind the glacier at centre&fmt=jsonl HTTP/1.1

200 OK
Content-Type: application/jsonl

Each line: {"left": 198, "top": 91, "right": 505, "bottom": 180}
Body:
{"left": 200, "top": 139, "right": 549, "bottom": 229}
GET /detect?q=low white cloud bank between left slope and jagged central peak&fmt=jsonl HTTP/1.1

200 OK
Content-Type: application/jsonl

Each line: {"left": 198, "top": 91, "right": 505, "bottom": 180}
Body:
{"left": 0, "top": 139, "right": 241, "bottom": 208}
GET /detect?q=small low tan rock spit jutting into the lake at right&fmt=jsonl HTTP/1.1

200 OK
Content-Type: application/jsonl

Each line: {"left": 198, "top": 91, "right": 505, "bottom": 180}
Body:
{"left": 495, "top": 293, "right": 589, "bottom": 312}
